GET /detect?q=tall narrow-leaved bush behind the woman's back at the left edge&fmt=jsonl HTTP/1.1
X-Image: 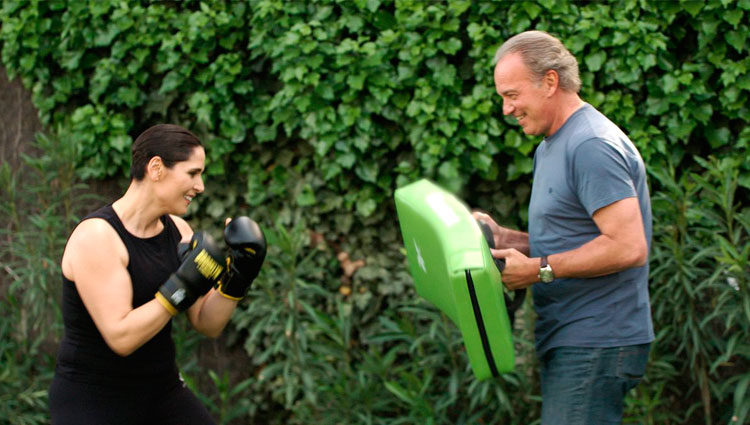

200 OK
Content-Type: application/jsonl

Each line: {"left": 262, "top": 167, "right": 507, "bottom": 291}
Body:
{"left": 0, "top": 134, "right": 91, "bottom": 425}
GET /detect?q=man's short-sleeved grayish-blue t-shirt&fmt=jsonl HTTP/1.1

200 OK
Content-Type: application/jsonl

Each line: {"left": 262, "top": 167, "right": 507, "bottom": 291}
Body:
{"left": 529, "top": 104, "right": 654, "bottom": 356}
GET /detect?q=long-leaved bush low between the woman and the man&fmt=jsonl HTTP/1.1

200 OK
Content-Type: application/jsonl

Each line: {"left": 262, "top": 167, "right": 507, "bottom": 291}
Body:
{"left": 234, "top": 217, "right": 538, "bottom": 424}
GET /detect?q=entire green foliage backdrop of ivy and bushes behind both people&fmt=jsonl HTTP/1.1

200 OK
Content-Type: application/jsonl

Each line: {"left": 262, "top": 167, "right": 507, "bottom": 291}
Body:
{"left": 0, "top": 0, "right": 750, "bottom": 424}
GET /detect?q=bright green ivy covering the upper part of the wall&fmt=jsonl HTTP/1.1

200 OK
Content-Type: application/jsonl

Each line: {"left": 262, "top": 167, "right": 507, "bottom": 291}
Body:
{"left": 2, "top": 0, "right": 750, "bottom": 203}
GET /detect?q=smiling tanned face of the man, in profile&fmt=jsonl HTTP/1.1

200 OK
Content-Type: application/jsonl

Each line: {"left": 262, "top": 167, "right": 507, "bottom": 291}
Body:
{"left": 495, "top": 53, "right": 552, "bottom": 135}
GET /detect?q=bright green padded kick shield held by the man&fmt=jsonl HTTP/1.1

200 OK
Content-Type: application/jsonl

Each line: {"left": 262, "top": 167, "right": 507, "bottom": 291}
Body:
{"left": 394, "top": 179, "right": 515, "bottom": 380}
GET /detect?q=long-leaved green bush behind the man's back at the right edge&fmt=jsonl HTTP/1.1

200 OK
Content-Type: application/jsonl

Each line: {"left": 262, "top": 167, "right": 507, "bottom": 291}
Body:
{"left": 649, "top": 157, "right": 750, "bottom": 424}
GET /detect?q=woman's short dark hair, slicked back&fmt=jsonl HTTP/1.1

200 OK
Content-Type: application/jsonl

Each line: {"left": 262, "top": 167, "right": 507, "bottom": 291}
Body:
{"left": 130, "top": 124, "right": 203, "bottom": 181}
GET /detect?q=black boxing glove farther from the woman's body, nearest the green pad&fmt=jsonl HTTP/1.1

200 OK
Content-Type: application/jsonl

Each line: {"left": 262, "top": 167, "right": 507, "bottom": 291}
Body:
{"left": 217, "top": 216, "right": 266, "bottom": 301}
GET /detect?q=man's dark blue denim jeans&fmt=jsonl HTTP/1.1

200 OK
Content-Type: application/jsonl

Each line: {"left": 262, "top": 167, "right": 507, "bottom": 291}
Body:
{"left": 540, "top": 344, "right": 651, "bottom": 425}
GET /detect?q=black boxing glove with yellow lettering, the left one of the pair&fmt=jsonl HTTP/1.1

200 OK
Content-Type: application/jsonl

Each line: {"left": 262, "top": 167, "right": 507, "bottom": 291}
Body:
{"left": 155, "top": 232, "right": 226, "bottom": 316}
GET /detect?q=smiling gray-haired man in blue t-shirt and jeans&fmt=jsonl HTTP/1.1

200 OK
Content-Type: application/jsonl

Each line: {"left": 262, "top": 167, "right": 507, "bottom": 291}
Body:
{"left": 474, "top": 31, "right": 654, "bottom": 425}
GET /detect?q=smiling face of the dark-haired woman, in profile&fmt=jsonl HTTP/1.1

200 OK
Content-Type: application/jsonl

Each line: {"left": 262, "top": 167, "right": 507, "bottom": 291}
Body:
{"left": 159, "top": 146, "right": 206, "bottom": 215}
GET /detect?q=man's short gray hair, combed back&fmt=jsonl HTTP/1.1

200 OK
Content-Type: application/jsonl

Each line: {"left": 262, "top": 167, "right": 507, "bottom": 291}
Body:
{"left": 492, "top": 31, "right": 581, "bottom": 93}
